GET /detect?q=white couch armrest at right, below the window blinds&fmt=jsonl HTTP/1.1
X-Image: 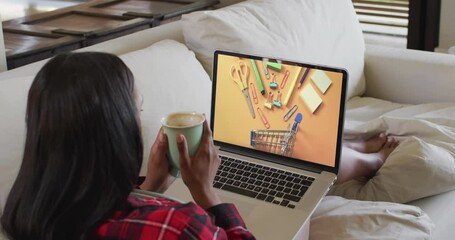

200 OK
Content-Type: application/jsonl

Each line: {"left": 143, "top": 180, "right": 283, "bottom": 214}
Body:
{"left": 365, "top": 45, "right": 455, "bottom": 104}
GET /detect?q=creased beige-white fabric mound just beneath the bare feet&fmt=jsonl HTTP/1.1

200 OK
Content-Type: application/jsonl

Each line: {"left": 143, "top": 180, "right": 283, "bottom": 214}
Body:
{"left": 329, "top": 137, "right": 455, "bottom": 203}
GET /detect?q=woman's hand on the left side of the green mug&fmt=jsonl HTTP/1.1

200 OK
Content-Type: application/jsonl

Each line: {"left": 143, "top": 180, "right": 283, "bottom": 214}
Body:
{"left": 139, "top": 129, "right": 175, "bottom": 193}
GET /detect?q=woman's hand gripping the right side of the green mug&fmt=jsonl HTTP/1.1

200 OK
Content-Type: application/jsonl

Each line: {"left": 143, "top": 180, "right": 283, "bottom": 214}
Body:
{"left": 177, "top": 120, "right": 221, "bottom": 209}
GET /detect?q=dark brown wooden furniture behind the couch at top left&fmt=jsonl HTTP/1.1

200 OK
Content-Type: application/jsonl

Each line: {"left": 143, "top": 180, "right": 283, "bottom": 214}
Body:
{"left": 3, "top": 0, "right": 219, "bottom": 69}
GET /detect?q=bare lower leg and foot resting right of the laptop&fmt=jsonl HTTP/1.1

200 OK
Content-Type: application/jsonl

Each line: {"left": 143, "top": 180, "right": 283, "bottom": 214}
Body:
{"left": 336, "top": 137, "right": 398, "bottom": 184}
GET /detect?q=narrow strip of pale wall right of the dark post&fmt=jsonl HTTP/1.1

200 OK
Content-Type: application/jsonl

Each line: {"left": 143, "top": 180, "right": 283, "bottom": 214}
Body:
{"left": 437, "top": 0, "right": 455, "bottom": 52}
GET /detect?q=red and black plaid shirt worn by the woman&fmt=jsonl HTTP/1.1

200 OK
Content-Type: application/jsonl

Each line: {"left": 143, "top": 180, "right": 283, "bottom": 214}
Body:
{"left": 93, "top": 190, "right": 255, "bottom": 240}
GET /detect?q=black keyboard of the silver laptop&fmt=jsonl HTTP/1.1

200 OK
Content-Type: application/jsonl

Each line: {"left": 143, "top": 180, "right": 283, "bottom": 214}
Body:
{"left": 213, "top": 155, "right": 314, "bottom": 208}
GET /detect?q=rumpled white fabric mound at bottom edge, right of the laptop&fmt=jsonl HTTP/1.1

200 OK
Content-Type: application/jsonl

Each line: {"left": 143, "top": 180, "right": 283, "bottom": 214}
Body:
{"left": 310, "top": 196, "right": 435, "bottom": 240}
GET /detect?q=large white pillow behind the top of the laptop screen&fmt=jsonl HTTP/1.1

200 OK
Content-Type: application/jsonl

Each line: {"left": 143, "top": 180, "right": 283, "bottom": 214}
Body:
{"left": 182, "top": 0, "right": 365, "bottom": 98}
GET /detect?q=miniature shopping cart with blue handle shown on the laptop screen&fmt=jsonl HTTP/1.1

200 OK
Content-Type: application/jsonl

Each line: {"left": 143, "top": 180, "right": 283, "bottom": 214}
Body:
{"left": 250, "top": 113, "right": 302, "bottom": 156}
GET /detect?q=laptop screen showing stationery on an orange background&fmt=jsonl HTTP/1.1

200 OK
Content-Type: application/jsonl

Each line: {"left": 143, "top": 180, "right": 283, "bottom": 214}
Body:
{"left": 212, "top": 51, "right": 347, "bottom": 171}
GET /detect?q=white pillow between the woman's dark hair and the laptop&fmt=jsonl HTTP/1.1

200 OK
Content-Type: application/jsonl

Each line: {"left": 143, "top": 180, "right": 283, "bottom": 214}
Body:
{"left": 120, "top": 40, "right": 212, "bottom": 176}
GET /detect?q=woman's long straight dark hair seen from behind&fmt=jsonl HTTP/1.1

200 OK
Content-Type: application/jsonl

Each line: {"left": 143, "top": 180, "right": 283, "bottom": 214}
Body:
{"left": 1, "top": 52, "right": 143, "bottom": 239}
